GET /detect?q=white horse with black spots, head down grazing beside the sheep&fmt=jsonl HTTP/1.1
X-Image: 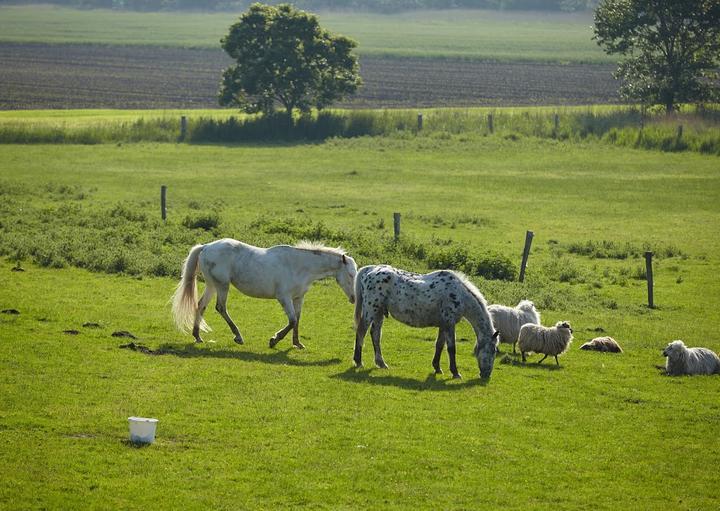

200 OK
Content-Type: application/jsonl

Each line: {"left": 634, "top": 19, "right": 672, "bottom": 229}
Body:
{"left": 353, "top": 265, "right": 498, "bottom": 378}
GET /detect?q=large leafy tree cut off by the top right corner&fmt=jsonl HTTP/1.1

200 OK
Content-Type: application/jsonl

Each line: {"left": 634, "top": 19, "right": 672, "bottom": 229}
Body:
{"left": 595, "top": 0, "right": 720, "bottom": 113}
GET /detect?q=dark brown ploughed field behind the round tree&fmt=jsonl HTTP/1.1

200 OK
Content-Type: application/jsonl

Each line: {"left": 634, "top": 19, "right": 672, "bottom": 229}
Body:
{"left": 0, "top": 43, "right": 618, "bottom": 110}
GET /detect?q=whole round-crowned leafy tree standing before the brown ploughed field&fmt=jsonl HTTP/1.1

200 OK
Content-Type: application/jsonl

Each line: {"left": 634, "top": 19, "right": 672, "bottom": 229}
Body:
{"left": 219, "top": 4, "right": 361, "bottom": 114}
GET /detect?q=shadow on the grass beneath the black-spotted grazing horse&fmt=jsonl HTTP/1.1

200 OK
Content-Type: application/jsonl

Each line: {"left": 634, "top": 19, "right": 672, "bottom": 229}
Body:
{"left": 330, "top": 367, "right": 488, "bottom": 391}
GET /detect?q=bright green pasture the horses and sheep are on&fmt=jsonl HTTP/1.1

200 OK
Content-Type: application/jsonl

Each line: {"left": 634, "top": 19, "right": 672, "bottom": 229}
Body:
{"left": 0, "top": 118, "right": 720, "bottom": 509}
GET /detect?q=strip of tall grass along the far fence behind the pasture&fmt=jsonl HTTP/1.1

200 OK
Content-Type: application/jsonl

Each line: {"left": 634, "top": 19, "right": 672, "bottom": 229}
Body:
{"left": 0, "top": 105, "right": 720, "bottom": 155}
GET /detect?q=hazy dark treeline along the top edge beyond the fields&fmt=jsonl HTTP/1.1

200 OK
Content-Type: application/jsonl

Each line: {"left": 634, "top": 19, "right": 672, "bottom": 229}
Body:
{"left": 0, "top": 0, "right": 597, "bottom": 12}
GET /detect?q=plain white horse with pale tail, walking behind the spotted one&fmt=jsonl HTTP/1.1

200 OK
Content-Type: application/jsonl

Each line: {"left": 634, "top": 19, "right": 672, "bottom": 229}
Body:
{"left": 172, "top": 238, "right": 357, "bottom": 348}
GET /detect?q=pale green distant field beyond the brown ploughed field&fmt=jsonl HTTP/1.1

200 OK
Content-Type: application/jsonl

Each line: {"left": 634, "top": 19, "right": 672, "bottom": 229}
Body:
{"left": 0, "top": 6, "right": 614, "bottom": 63}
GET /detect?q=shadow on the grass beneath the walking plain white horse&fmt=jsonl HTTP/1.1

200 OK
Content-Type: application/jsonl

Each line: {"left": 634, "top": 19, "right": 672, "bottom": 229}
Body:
{"left": 156, "top": 344, "right": 341, "bottom": 367}
